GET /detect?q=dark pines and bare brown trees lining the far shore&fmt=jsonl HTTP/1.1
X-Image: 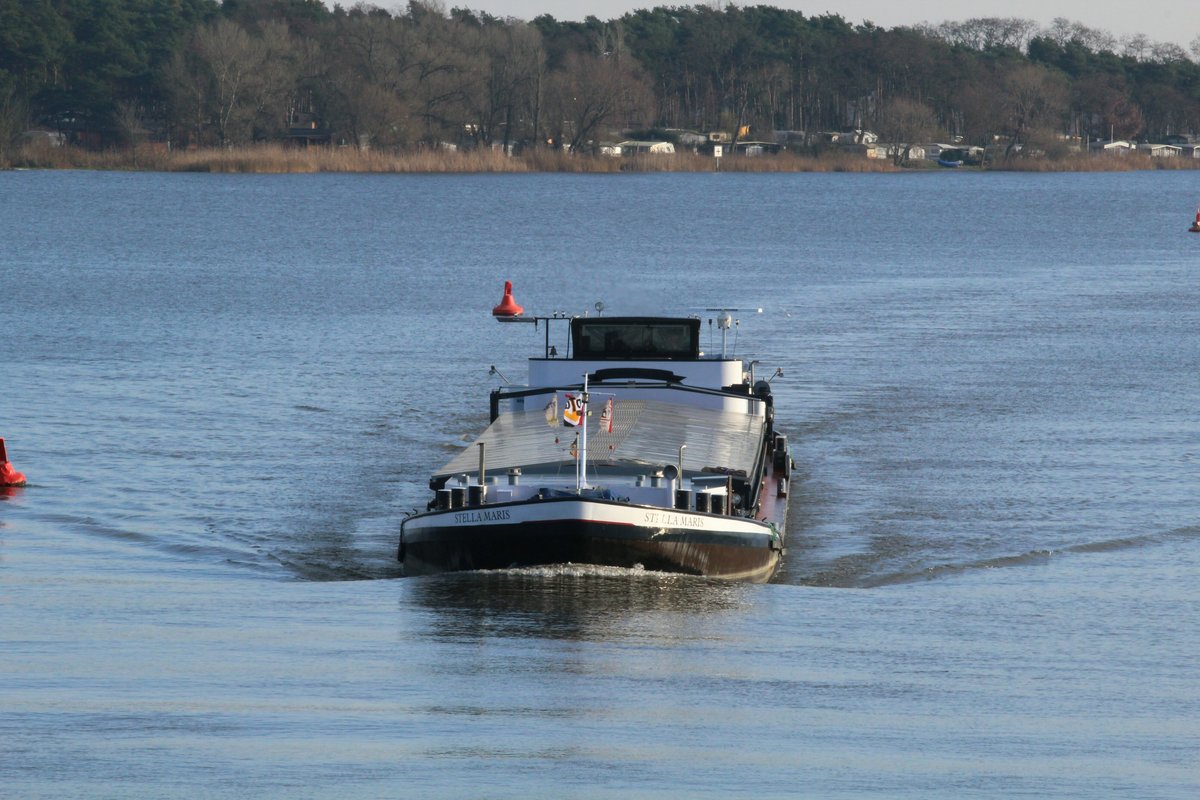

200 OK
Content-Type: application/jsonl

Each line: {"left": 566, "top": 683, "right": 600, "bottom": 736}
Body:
{"left": 0, "top": 0, "right": 1200, "bottom": 155}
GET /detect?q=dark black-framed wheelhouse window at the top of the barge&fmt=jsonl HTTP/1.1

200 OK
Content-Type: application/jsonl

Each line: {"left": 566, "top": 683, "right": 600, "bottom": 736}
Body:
{"left": 571, "top": 317, "right": 700, "bottom": 360}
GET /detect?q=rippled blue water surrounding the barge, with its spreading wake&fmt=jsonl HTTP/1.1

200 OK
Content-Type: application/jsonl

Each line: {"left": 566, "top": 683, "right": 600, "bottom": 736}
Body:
{"left": 0, "top": 167, "right": 1200, "bottom": 798}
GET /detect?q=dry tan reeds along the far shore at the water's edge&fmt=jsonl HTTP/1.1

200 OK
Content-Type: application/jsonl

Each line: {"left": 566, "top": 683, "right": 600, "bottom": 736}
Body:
{"left": 10, "top": 144, "right": 1200, "bottom": 174}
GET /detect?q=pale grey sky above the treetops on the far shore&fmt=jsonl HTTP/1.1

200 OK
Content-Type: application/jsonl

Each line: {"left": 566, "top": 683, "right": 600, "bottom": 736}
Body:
{"left": 388, "top": 0, "right": 1200, "bottom": 49}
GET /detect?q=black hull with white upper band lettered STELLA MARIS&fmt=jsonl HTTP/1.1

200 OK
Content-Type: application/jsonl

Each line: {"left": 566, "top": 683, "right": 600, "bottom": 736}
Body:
{"left": 398, "top": 498, "right": 782, "bottom": 583}
